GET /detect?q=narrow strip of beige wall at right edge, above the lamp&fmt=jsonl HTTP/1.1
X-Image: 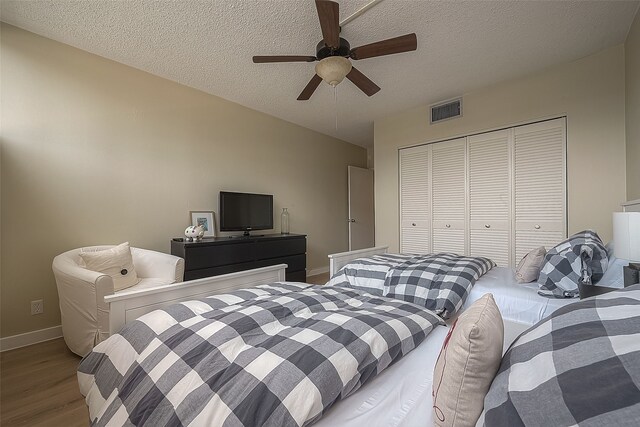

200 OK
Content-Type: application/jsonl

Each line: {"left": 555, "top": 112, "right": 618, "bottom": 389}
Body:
{"left": 624, "top": 11, "right": 640, "bottom": 200}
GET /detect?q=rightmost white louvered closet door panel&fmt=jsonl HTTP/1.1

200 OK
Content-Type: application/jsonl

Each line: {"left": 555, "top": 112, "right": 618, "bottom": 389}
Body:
{"left": 514, "top": 118, "right": 566, "bottom": 263}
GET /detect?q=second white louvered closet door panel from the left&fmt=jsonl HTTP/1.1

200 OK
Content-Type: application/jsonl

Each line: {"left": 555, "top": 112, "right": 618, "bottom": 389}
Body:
{"left": 431, "top": 138, "right": 467, "bottom": 255}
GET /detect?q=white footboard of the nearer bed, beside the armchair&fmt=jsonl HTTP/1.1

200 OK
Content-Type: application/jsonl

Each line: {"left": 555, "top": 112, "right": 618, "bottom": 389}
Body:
{"left": 104, "top": 264, "right": 287, "bottom": 335}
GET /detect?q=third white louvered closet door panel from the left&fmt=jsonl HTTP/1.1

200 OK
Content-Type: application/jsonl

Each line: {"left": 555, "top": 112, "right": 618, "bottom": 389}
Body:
{"left": 468, "top": 129, "right": 513, "bottom": 267}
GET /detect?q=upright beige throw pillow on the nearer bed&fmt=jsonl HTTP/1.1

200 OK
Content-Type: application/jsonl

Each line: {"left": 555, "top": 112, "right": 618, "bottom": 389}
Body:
{"left": 433, "top": 294, "right": 504, "bottom": 427}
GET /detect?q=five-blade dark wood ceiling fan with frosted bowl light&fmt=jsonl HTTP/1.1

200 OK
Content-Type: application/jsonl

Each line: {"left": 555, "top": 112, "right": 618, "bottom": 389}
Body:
{"left": 253, "top": 0, "right": 418, "bottom": 101}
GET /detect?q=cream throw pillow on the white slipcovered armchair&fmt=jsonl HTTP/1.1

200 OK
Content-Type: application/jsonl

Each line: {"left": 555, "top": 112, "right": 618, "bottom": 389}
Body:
{"left": 80, "top": 242, "right": 140, "bottom": 292}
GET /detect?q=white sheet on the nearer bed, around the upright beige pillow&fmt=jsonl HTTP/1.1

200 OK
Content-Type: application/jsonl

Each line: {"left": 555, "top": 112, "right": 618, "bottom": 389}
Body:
{"left": 314, "top": 321, "right": 529, "bottom": 427}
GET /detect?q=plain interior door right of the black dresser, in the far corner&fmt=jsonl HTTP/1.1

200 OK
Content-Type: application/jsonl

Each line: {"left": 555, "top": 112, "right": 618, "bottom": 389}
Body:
{"left": 348, "top": 166, "right": 375, "bottom": 251}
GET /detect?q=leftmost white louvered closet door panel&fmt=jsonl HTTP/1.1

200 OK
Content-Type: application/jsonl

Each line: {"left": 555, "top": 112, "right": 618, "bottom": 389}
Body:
{"left": 400, "top": 145, "right": 431, "bottom": 254}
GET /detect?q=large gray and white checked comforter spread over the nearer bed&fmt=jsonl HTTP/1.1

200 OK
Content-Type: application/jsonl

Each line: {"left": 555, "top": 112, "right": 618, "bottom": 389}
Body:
{"left": 78, "top": 283, "right": 442, "bottom": 426}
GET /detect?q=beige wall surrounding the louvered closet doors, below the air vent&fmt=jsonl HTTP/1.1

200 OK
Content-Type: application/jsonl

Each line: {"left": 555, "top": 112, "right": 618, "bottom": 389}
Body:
{"left": 374, "top": 45, "right": 626, "bottom": 254}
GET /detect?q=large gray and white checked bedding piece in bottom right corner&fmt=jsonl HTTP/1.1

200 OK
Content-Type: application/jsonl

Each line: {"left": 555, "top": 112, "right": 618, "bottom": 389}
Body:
{"left": 484, "top": 285, "right": 640, "bottom": 427}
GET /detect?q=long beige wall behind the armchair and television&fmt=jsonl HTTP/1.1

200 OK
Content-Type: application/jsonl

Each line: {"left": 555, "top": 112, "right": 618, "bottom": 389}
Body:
{"left": 1, "top": 24, "right": 367, "bottom": 336}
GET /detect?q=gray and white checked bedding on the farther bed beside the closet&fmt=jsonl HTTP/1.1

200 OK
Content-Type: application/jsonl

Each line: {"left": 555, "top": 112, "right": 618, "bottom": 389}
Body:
{"left": 328, "top": 253, "right": 495, "bottom": 319}
